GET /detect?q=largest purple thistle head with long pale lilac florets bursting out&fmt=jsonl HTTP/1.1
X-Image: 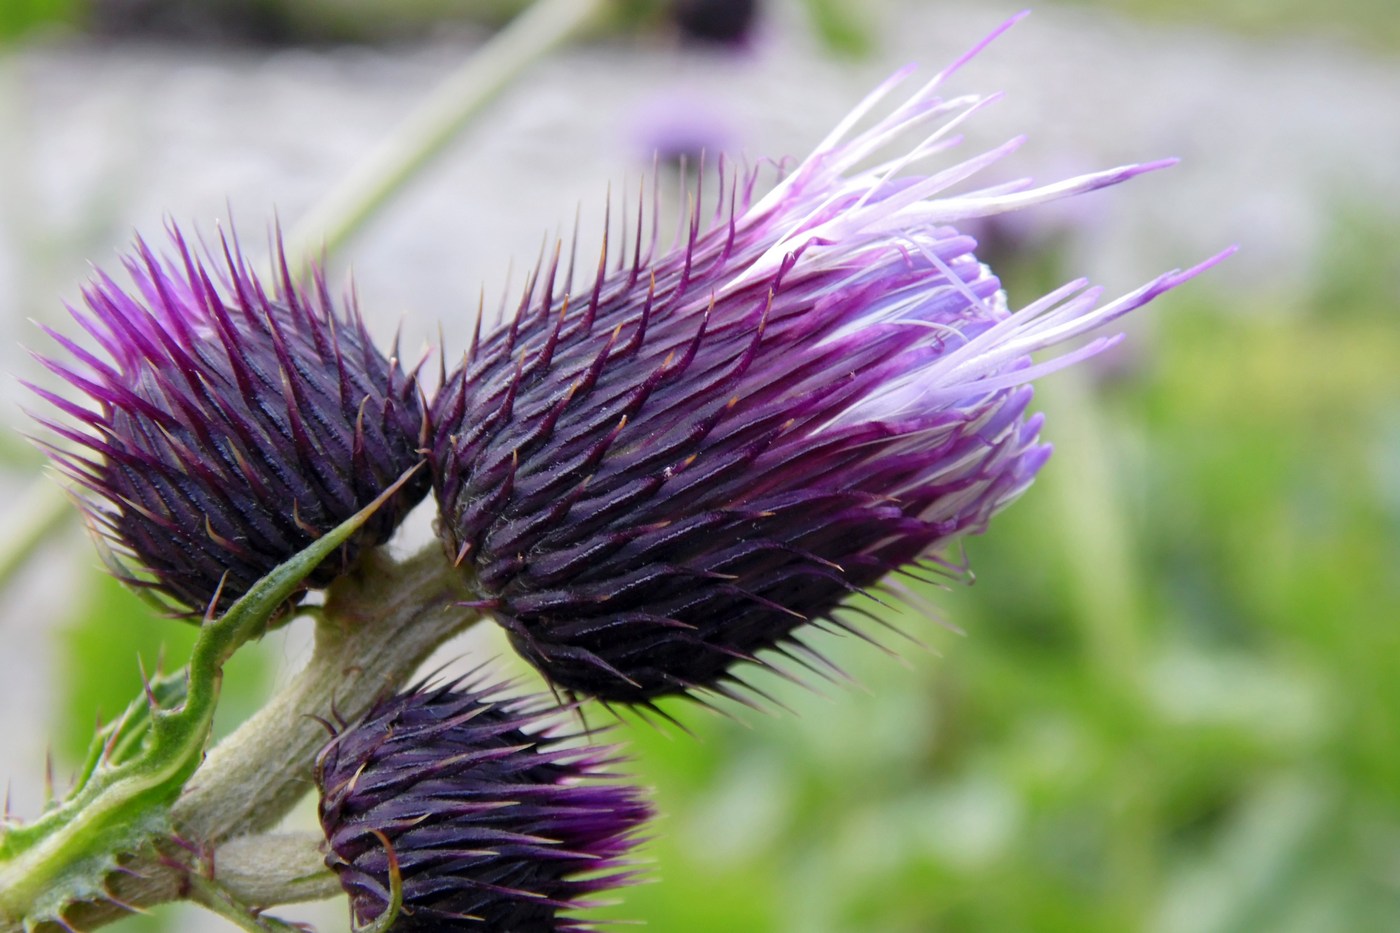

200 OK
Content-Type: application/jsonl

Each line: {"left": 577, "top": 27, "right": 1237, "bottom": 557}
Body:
{"left": 431, "top": 14, "right": 1224, "bottom": 702}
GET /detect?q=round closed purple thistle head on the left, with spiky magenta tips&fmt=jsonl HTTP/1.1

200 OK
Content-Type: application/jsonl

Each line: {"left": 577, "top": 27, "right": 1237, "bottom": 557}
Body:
{"left": 31, "top": 227, "right": 430, "bottom": 614}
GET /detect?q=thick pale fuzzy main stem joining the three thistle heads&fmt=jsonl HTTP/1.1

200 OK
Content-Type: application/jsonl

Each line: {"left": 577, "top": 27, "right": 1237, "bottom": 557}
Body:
{"left": 10, "top": 544, "right": 479, "bottom": 933}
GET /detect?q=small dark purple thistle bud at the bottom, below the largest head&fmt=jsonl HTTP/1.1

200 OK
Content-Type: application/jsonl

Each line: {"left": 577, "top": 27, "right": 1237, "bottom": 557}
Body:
{"left": 316, "top": 672, "right": 651, "bottom": 933}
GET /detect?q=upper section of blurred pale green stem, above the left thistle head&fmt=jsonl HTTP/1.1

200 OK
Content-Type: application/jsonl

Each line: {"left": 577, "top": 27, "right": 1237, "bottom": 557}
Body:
{"left": 287, "top": 0, "right": 612, "bottom": 268}
